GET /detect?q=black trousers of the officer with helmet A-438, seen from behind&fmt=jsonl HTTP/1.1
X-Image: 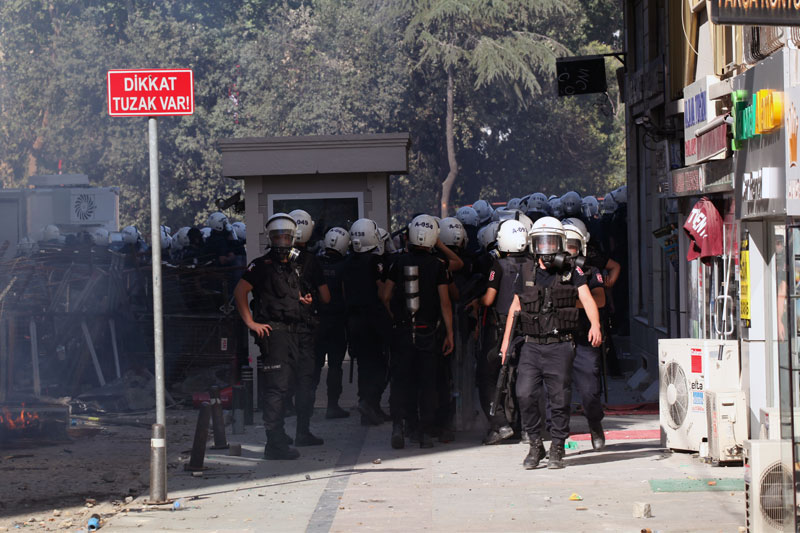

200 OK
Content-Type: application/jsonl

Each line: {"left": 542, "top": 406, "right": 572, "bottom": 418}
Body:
{"left": 347, "top": 312, "right": 388, "bottom": 406}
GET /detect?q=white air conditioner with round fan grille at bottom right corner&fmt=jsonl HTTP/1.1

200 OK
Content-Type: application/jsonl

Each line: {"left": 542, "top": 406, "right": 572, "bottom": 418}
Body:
{"left": 744, "top": 440, "right": 794, "bottom": 533}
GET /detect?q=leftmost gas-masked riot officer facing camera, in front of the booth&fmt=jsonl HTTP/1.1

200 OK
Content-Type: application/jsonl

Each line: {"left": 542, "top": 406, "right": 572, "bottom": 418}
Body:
{"left": 234, "top": 213, "right": 316, "bottom": 459}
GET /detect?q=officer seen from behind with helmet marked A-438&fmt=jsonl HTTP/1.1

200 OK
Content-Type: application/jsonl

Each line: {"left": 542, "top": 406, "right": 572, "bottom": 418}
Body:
{"left": 342, "top": 218, "right": 388, "bottom": 425}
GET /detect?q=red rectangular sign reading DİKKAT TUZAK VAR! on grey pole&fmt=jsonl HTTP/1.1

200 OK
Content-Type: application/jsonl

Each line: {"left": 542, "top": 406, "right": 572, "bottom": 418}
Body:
{"left": 107, "top": 69, "right": 194, "bottom": 117}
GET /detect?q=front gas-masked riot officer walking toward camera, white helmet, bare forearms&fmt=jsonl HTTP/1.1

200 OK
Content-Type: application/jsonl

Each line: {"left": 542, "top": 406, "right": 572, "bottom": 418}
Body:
{"left": 501, "top": 217, "right": 602, "bottom": 470}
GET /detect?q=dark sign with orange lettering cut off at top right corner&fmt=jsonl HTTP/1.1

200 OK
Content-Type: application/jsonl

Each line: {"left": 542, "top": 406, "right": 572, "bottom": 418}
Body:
{"left": 710, "top": 0, "right": 800, "bottom": 26}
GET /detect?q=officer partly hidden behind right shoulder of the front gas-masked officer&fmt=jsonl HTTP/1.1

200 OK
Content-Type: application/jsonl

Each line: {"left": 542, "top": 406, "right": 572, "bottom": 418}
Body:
{"left": 561, "top": 218, "right": 606, "bottom": 450}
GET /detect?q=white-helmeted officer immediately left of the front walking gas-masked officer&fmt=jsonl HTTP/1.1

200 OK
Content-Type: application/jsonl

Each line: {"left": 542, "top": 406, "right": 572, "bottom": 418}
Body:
{"left": 477, "top": 220, "right": 535, "bottom": 445}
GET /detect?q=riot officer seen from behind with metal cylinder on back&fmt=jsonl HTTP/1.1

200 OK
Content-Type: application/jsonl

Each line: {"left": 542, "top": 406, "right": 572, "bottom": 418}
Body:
{"left": 381, "top": 215, "right": 453, "bottom": 449}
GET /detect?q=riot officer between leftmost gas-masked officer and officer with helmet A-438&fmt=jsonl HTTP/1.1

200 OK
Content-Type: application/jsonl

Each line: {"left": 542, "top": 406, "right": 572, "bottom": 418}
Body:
{"left": 314, "top": 227, "right": 350, "bottom": 418}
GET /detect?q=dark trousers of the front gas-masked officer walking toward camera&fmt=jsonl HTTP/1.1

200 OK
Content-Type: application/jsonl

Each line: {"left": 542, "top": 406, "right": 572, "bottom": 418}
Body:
{"left": 516, "top": 342, "right": 575, "bottom": 443}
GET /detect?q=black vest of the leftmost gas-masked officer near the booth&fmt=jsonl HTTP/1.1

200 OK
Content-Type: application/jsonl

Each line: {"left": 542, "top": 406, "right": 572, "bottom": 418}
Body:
{"left": 253, "top": 259, "right": 302, "bottom": 324}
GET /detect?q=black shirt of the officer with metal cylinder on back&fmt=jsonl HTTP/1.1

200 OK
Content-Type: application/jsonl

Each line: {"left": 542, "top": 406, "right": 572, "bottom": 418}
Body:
{"left": 388, "top": 251, "right": 449, "bottom": 324}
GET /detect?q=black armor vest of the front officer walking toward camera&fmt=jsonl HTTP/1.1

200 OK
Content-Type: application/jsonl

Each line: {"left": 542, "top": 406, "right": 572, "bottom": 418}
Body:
{"left": 519, "top": 273, "right": 578, "bottom": 337}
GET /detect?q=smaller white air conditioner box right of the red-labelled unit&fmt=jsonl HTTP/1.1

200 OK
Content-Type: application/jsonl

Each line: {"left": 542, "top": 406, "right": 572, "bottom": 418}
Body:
{"left": 706, "top": 389, "right": 750, "bottom": 463}
